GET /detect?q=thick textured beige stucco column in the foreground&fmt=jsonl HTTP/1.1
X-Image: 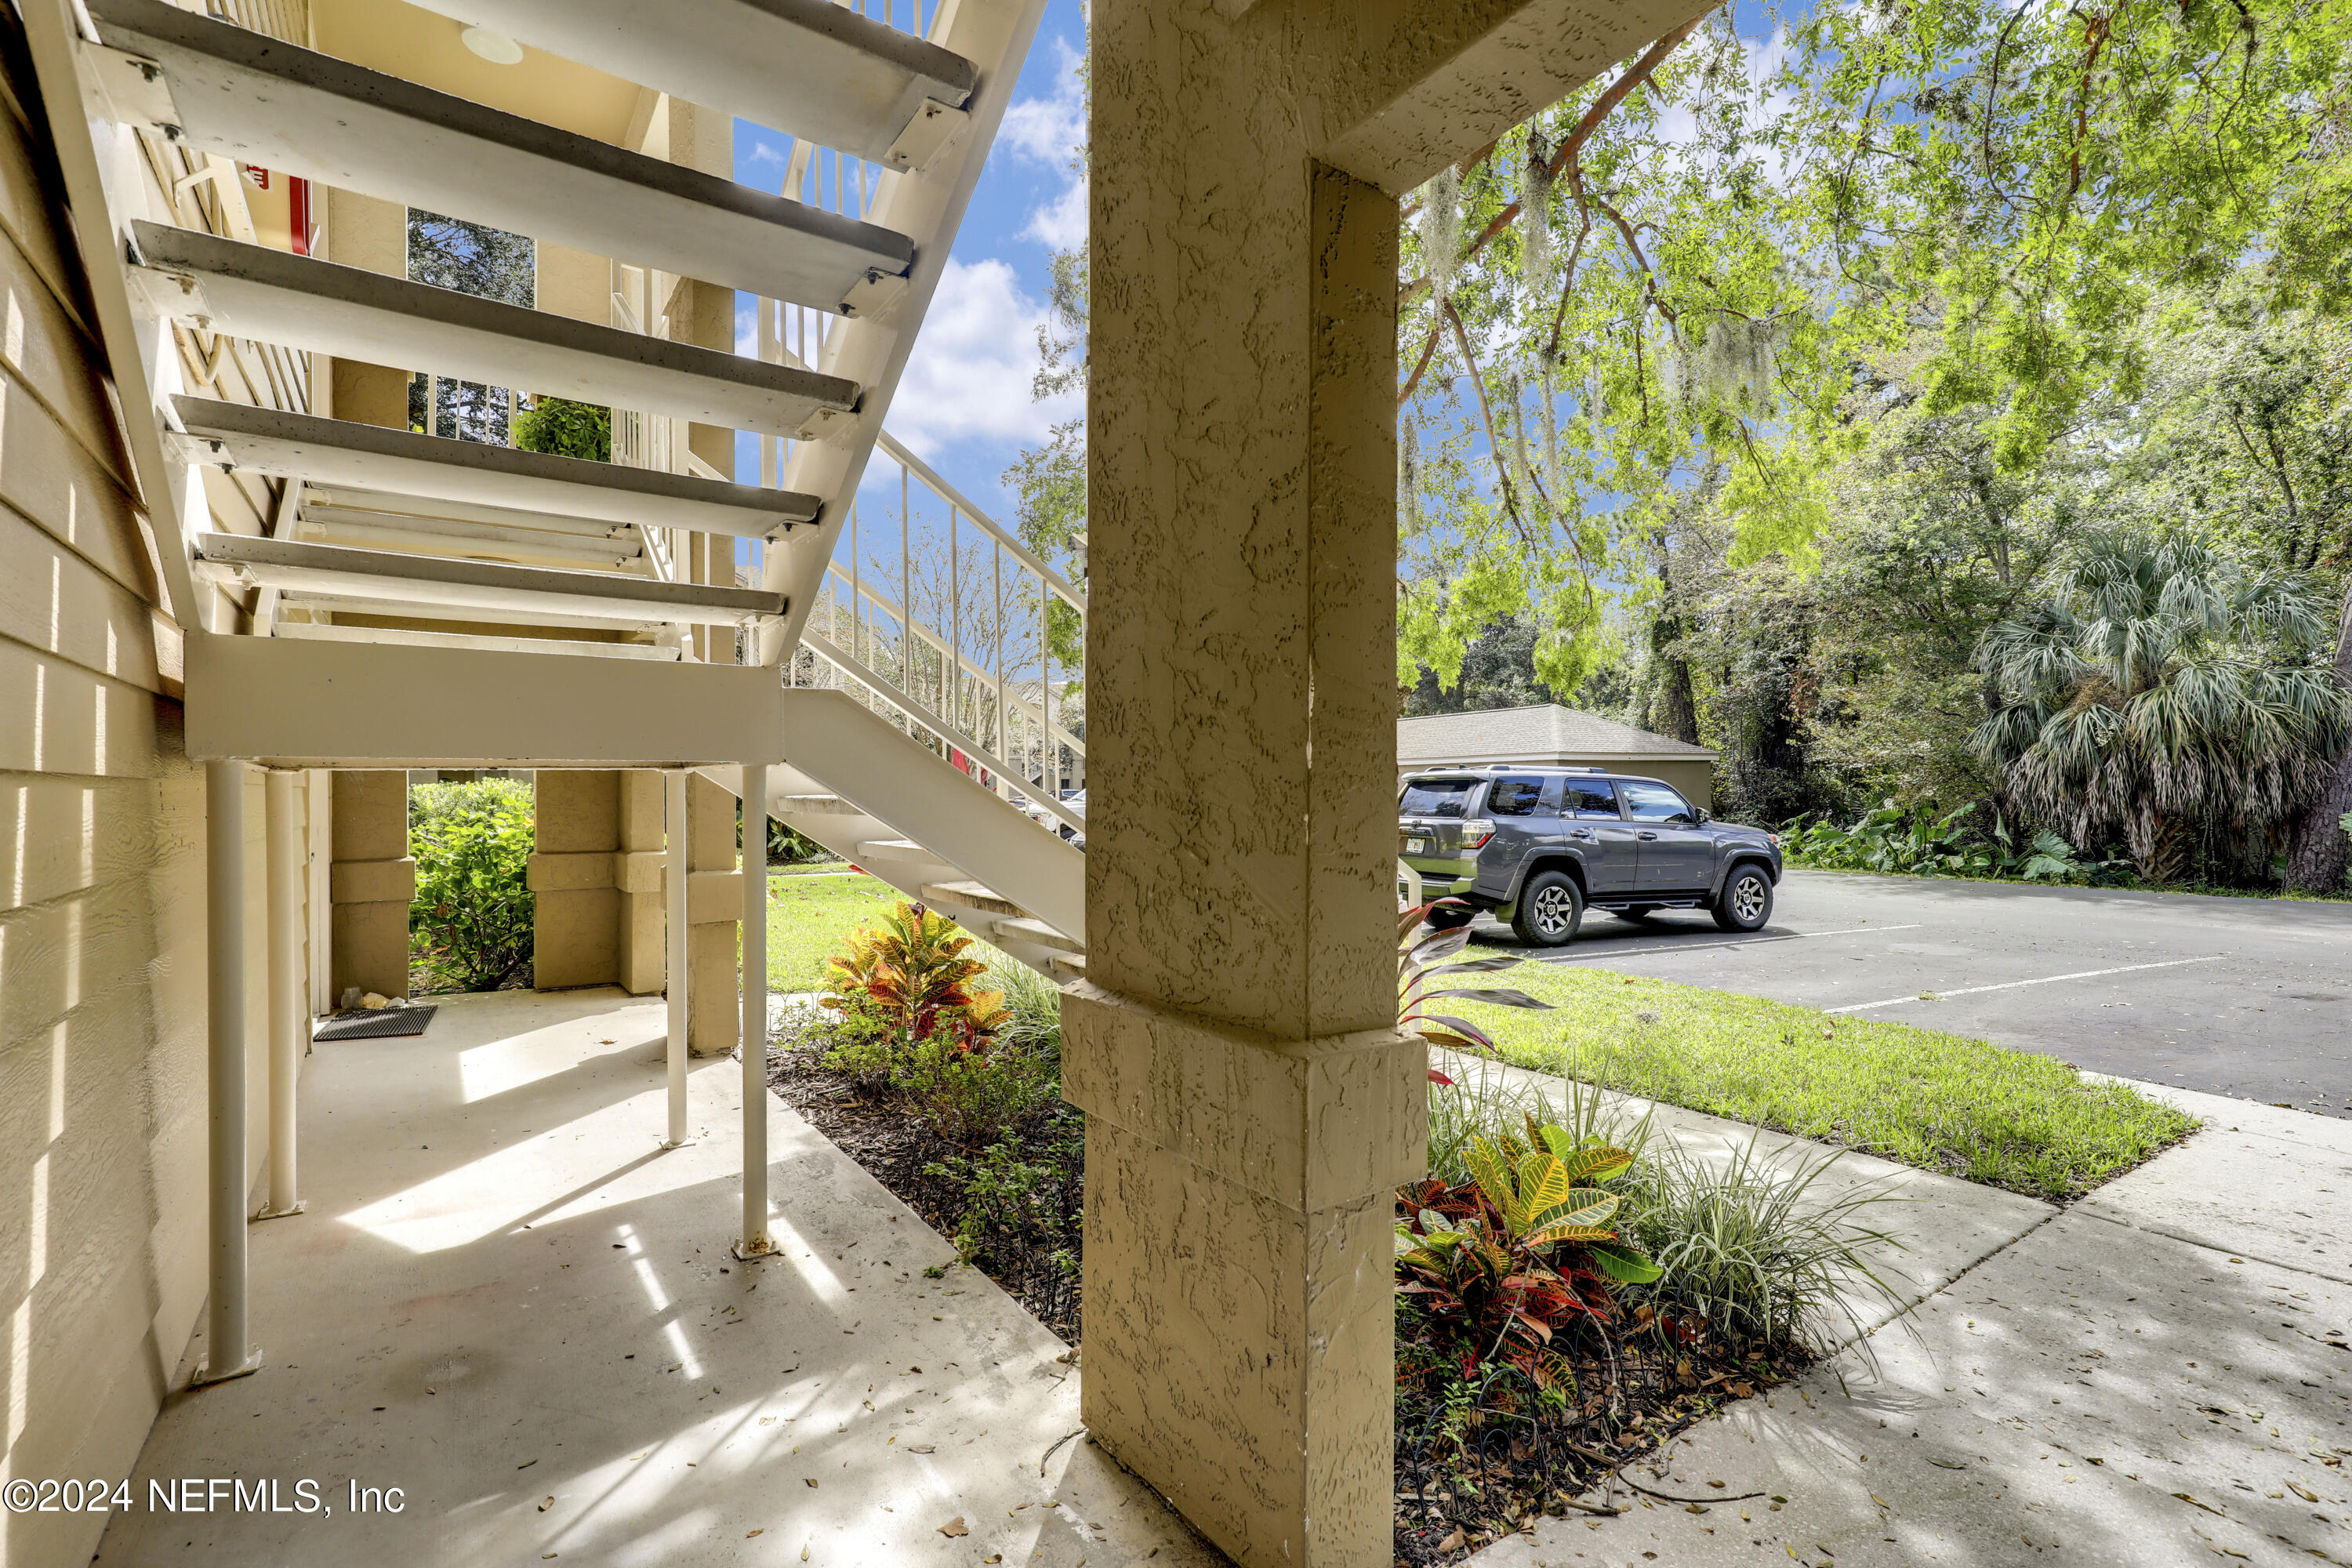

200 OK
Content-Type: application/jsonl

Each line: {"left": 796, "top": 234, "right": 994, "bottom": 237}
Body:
{"left": 1063, "top": 12, "right": 1428, "bottom": 1568}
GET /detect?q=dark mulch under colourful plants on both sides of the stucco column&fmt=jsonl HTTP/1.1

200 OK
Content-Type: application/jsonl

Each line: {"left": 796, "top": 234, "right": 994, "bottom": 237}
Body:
{"left": 767, "top": 1022, "right": 1802, "bottom": 1568}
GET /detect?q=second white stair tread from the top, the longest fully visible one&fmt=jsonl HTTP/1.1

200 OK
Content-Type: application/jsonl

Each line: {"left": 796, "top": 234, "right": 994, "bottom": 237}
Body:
{"left": 89, "top": 0, "right": 915, "bottom": 310}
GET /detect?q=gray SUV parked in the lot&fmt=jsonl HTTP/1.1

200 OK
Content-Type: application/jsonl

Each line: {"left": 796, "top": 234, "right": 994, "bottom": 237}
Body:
{"left": 1397, "top": 764, "right": 1780, "bottom": 947}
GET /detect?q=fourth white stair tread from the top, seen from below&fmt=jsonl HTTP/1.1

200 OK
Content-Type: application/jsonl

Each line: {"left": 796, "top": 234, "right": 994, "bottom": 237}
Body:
{"left": 172, "top": 397, "right": 818, "bottom": 539}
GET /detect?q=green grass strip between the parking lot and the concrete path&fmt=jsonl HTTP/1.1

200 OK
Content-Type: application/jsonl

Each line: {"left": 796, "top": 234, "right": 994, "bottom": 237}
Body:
{"left": 1461, "top": 964, "right": 2197, "bottom": 1199}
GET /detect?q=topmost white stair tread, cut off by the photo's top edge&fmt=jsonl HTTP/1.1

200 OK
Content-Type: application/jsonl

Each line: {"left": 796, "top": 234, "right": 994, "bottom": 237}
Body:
{"left": 395, "top": 0, "right": 978, "bottom": 162}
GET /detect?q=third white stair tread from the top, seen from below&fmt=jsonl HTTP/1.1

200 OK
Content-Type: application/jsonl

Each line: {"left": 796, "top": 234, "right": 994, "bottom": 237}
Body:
{"left": 132, "top": 221, "right": 858, "bottom": 440}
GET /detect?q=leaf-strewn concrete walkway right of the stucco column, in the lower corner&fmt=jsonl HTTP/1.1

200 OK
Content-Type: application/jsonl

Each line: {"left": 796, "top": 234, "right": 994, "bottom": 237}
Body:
{"left": 1472, "top": 1086, "right": 2352, "bottom": 1568}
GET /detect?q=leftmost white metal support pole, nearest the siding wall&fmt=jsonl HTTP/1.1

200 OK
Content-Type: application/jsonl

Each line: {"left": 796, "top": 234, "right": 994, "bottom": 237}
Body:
{"left": 193, "top": 762, "right": 261, "bottom": 1382}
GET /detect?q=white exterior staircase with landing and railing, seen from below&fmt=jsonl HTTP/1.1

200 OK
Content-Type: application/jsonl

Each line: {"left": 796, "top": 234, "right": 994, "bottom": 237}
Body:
{"left": 24, "top": 0, "right": 1084, "bottom": 978}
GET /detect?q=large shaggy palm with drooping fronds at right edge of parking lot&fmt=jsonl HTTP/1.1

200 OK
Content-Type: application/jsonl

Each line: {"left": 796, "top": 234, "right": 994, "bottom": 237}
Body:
{"left": 1971, "top": 534, "right": 2352, "bottom": 884}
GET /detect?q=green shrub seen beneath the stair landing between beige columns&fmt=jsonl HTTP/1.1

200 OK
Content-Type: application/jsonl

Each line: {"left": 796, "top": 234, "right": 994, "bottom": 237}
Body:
{"left": 409, "top": 779, "right": 536, "bottom": 992}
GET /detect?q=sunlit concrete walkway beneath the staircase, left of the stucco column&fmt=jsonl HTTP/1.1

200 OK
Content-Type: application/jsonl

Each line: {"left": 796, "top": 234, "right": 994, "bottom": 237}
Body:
{"left": 96, "top": 989, "right": 1221, "bottom": 1568}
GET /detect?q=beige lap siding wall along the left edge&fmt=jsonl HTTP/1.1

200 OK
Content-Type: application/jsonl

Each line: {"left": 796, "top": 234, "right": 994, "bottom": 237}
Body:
{"left": 0, "top": 34, "right": 268, "bottom": 1563}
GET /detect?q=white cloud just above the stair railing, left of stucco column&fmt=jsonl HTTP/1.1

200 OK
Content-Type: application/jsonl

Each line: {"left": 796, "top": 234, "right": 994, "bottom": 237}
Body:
{"left": 889, "top": 256, "right": 1084, "bottom": 459}
